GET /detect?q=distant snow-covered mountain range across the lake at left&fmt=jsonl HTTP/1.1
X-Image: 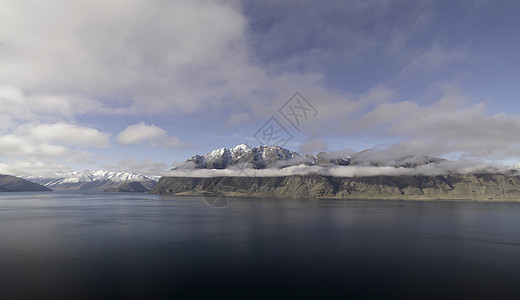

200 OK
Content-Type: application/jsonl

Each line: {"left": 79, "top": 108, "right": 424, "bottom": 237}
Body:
{"left": 25, "top": 170, "right": 159, "bottom": 191}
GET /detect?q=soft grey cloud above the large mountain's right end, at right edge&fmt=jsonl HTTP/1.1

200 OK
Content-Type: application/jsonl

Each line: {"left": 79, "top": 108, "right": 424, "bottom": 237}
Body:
{"left": 338, "top": 84, "right": 520, "bottom": 159}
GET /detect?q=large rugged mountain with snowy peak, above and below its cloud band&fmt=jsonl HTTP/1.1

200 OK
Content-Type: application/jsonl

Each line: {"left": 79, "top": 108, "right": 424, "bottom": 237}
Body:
{"left": 151, "top": 145, "right": 520, "bottom": 201}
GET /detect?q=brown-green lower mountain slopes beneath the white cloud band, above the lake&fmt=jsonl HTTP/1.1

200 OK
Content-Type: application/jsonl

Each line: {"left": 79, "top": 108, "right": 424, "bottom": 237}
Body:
{"left": 151, "top": 172, "right": 520, "bottom": 201}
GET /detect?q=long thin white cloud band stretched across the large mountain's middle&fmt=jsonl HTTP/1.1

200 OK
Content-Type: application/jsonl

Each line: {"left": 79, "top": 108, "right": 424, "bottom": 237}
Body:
{"left": 166, "top": 161, "right": 511, "bottom": 178}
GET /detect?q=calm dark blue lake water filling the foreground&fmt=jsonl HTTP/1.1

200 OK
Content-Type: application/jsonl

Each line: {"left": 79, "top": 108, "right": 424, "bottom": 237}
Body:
{"left": 0, "top": 192, "right": 520, "bottom": 299}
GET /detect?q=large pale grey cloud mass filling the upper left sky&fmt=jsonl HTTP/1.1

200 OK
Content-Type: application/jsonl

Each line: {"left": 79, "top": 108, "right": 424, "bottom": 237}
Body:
{"left": 0, "top": 0, "right": 378, "bottom": 122}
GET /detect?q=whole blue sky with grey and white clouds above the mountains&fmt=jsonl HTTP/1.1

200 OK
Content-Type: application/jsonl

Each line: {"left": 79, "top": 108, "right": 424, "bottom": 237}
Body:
{"left": 0, "top": 0, "right": 520, "bottom": 176}
